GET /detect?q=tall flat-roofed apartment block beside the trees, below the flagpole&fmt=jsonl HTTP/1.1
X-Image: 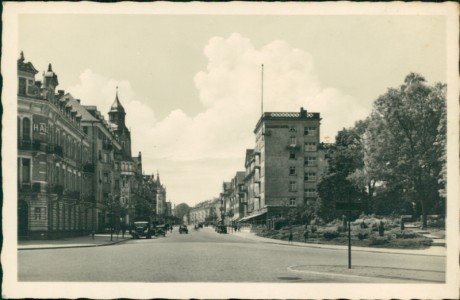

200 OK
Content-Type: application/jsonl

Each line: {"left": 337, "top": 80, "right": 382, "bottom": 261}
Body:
{"left": 241, "top": 108, "right": 324, "bottom": 225}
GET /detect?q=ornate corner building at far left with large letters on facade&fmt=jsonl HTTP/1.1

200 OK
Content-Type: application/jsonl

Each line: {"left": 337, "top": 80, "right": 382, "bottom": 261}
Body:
{"left": 17, "top": 52, "right": 93, "bottom": 238}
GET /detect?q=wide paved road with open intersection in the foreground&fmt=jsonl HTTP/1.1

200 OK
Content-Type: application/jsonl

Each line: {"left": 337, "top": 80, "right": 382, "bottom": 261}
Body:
{"left": 18, "top": 227, "right": 445, "bottom": 283}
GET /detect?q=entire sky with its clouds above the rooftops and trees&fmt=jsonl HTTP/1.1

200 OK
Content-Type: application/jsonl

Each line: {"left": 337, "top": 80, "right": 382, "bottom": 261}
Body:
{"left": 18, "top": 14, "right": 447, "bottom": 205}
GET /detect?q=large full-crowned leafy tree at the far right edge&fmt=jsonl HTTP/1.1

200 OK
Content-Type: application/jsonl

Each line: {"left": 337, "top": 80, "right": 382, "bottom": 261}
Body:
{"left": 366, "top": 73, "right": 446, "bottom": 227}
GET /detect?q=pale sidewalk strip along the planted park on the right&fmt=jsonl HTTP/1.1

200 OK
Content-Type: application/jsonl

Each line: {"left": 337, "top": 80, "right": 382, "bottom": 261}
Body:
{"left": 231, "top": 231, "right": 446, "bottom": 256}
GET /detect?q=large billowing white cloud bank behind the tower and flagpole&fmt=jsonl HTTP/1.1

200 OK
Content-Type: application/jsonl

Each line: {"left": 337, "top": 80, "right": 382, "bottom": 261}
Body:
{"left": 69, "top": 33, "right": 369, "bottom": 206}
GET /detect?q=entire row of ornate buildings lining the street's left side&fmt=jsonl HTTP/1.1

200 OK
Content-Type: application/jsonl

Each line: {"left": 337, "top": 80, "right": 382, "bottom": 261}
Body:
{"left": 17, "top": 53, "right": 171, "bottom": 237}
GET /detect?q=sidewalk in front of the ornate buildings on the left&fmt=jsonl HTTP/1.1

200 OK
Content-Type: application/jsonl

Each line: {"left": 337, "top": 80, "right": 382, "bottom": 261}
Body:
{"left": 18, "top": 234, "right": 131, "bottom": 250}
